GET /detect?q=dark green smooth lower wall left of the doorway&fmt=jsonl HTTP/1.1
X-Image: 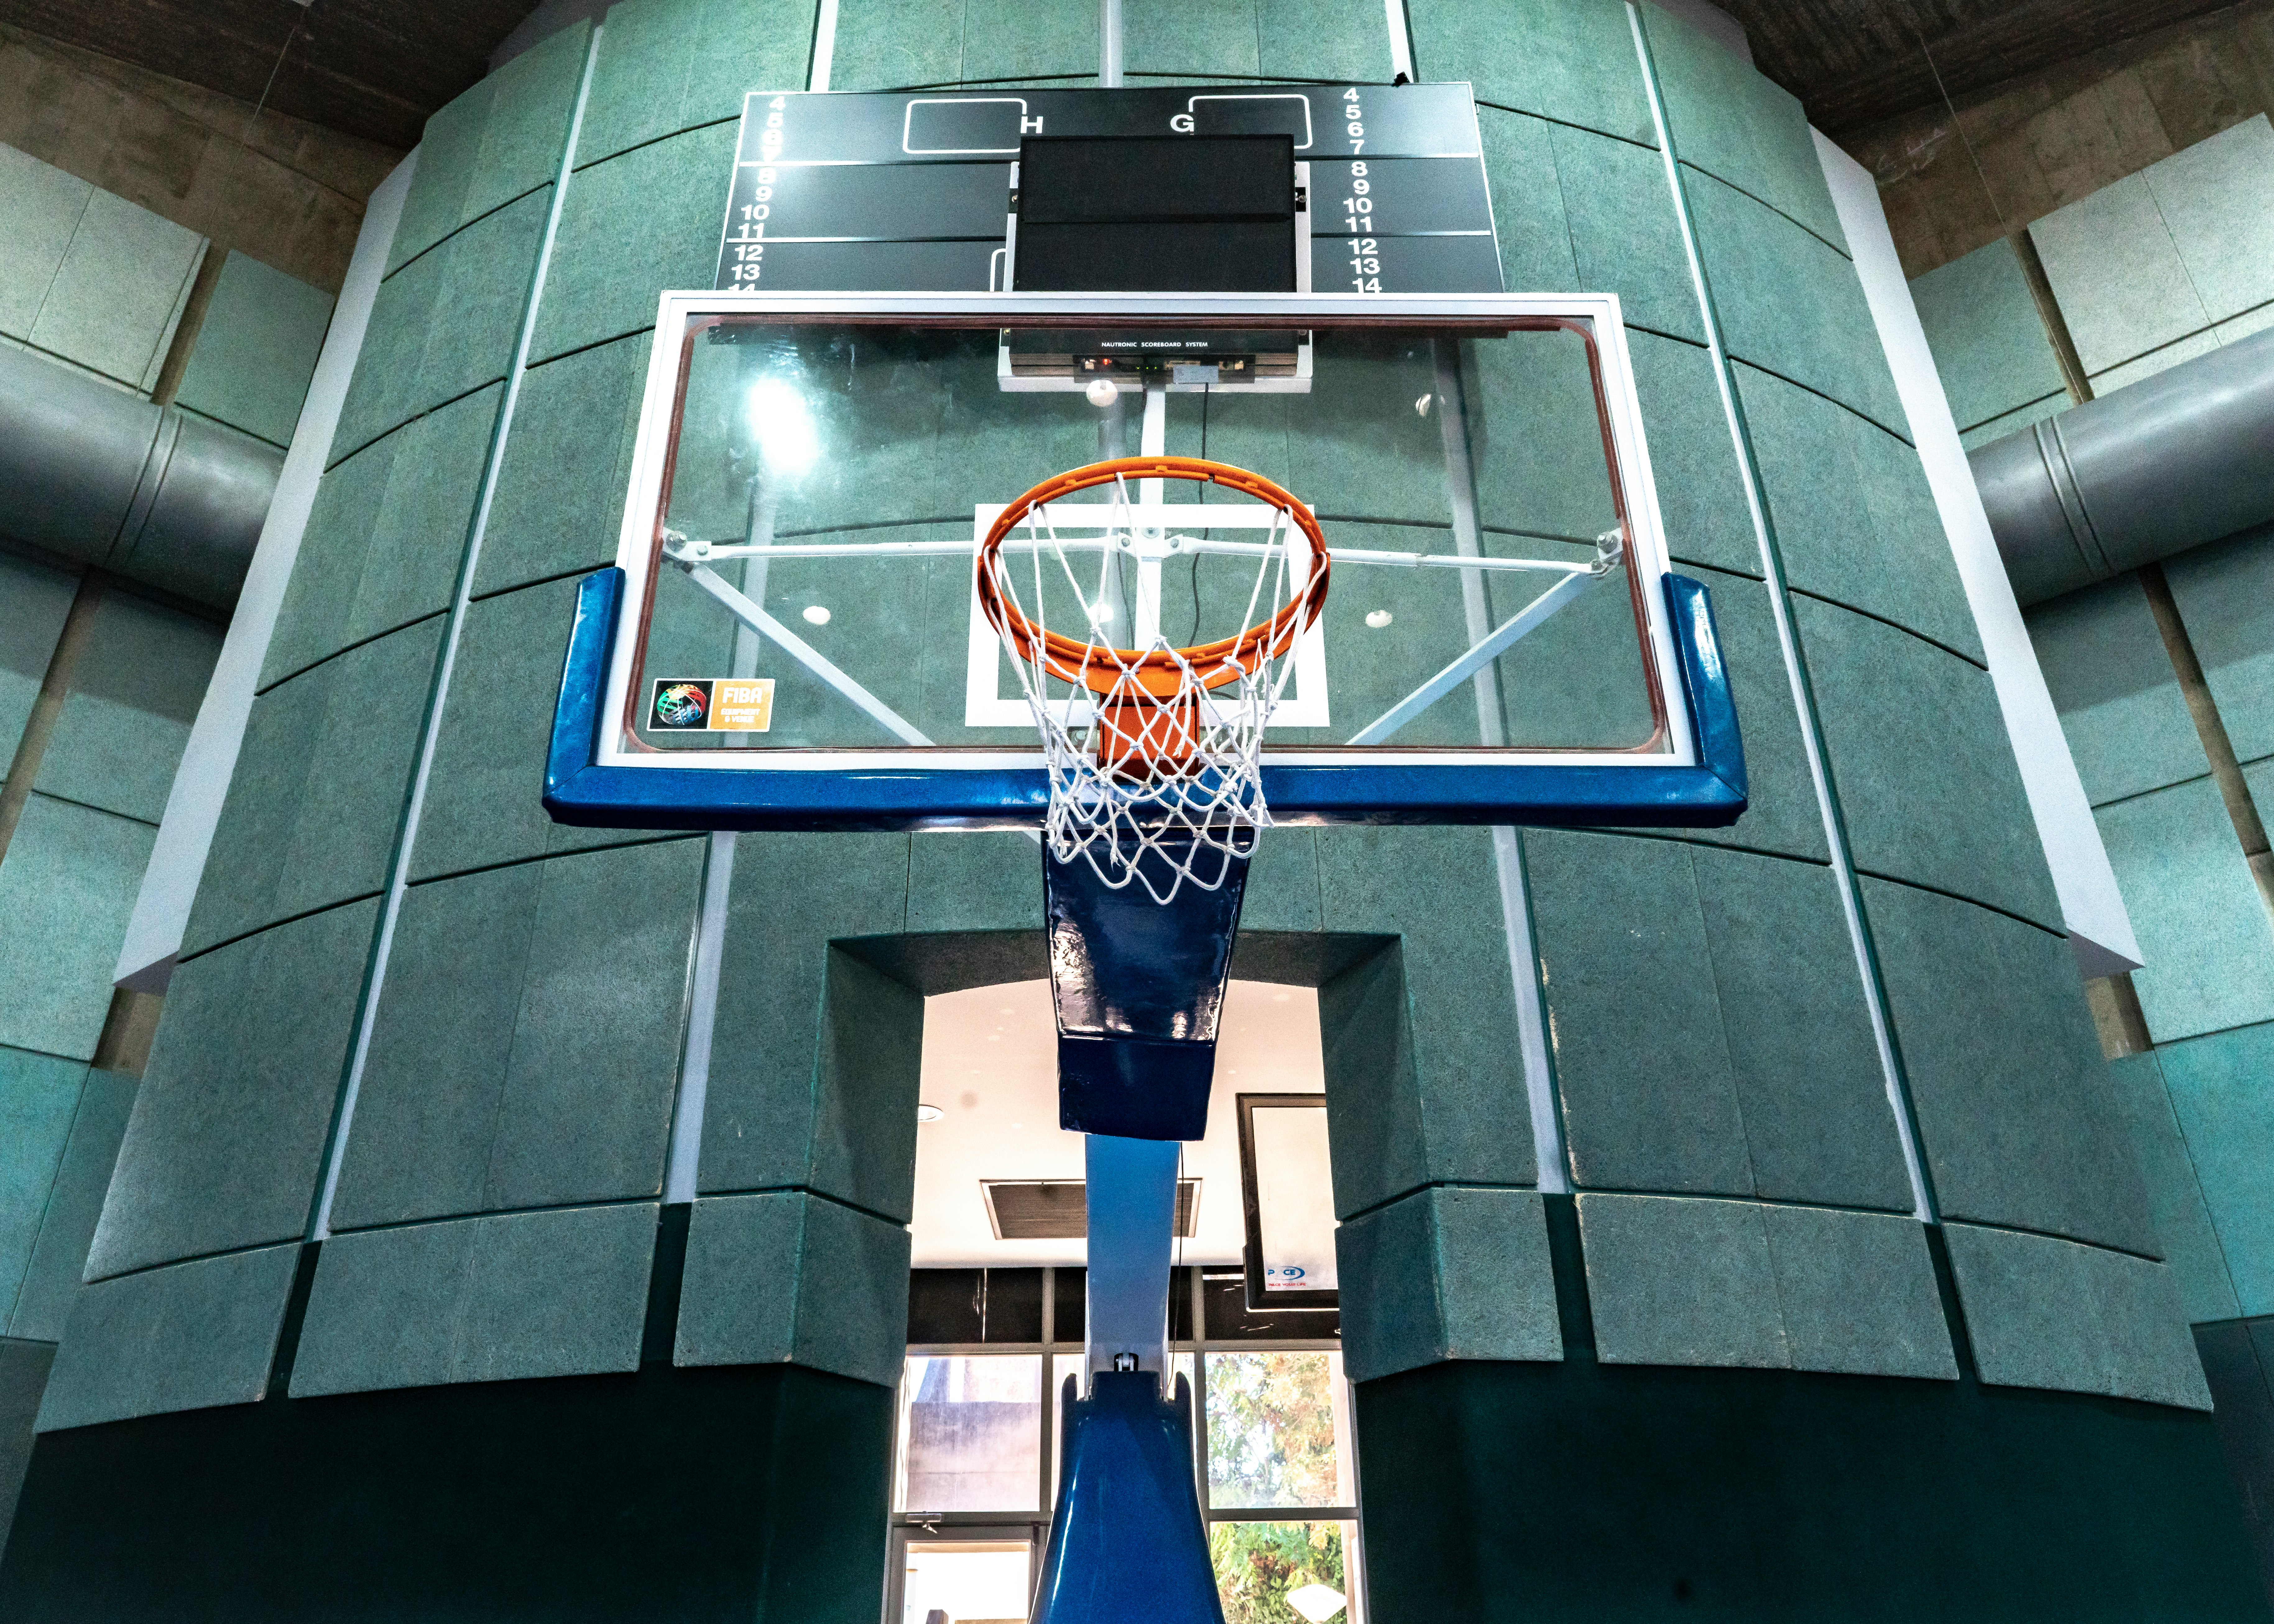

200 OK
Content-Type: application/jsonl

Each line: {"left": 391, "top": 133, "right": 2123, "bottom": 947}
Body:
{"left": 0, "top": 1365, "right": 894, "bottom": 1624}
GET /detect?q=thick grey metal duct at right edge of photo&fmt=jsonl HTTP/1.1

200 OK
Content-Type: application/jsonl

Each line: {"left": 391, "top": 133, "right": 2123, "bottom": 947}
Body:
{"left": 1969, "top": 328, "right": 2274, "bottom": 605}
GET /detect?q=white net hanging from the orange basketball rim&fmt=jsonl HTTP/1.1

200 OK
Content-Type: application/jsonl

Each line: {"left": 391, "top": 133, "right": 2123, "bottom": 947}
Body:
{"left": 994, "top": 478, "right": 1310, "bottom": 903}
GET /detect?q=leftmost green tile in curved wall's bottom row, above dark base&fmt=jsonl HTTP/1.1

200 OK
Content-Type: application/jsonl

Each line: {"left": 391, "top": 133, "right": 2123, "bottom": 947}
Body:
{"left": 39, "top": 1244, "right": 300, "bottom": 1433}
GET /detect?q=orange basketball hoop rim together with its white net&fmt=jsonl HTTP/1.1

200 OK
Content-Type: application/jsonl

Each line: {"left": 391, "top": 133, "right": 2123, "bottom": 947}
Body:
{"left": 978, "top": 457, "right": 1333, "bottom": 903}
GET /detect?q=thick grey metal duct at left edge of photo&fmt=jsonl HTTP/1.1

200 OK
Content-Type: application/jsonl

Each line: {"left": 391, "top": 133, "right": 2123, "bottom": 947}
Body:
{"left": 0, "top": 346, "right": 284, "bottom": 610}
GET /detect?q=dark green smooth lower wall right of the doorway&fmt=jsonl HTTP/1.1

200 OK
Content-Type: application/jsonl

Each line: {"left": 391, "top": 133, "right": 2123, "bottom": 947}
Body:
{"left": 1358, "top": 1360, "right": 2269, "bottom": 1624}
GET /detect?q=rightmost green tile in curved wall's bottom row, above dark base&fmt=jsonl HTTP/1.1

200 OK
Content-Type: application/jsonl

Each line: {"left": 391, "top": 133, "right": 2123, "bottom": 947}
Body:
{"left": 1942, "top": 1224, "right": 2210, "bottom": 1410}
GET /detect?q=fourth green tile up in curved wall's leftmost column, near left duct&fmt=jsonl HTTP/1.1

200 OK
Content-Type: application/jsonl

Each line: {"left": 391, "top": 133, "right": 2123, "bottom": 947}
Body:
{"left": 261, "top": 384, "right": 505, "bottom": 687}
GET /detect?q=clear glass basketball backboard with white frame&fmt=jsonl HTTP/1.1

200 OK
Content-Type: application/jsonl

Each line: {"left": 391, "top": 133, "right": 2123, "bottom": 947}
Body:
{"left": 602, "top": 296, "right": 1692, "bottom": 787}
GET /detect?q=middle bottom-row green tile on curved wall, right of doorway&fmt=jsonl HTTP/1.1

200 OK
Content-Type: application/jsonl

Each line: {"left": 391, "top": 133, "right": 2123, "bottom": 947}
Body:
{"left": 1578, "top": 1194, "right": 1958, "bottom": 1381}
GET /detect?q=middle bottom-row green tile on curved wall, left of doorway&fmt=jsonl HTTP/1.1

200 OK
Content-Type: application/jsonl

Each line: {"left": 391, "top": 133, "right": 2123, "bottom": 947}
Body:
{"left": 291, "top": 1201, "right": 655, "bottom": 1399}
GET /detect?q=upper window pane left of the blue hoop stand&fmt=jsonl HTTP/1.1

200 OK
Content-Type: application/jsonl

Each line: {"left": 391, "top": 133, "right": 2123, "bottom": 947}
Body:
{"left": 898, "top": 1353, "right": 1041, "bottom": 1510}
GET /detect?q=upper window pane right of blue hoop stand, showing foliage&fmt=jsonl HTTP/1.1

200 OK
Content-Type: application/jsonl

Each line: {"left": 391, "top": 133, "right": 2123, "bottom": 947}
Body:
{"left": 1207, "top": 1353, "right": 1351, "bottom": 1510}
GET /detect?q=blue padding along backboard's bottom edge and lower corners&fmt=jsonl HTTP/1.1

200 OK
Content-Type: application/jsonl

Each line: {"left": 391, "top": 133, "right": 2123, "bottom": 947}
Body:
{"left": 546, "top": 566, "right": 1746, "bottom": 830}
